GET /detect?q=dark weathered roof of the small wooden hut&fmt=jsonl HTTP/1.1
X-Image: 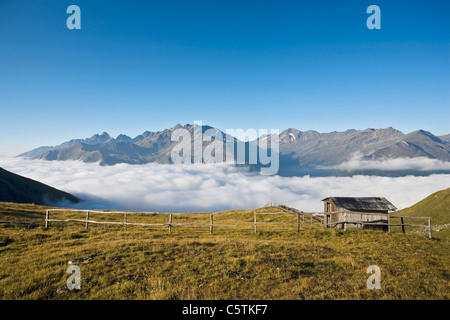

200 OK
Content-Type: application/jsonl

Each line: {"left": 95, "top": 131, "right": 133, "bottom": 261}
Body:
{"left": 322, "top": 197, "right": 397, "bottom": 211}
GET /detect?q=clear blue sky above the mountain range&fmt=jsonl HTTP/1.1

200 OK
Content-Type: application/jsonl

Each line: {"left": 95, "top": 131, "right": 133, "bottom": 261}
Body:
{"left": 0, "top": 0, "right": 450, "bottom": 153}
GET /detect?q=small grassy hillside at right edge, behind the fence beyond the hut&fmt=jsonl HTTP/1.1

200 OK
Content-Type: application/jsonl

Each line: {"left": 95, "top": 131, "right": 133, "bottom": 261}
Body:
{"left": 395, "top": 188, "right": 450, "bottom": 239}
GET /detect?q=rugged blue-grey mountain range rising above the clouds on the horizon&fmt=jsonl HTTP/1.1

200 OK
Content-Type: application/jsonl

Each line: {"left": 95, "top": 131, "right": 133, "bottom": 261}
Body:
{"left": 19, "top": 124, "right": 450, "bottom": 176}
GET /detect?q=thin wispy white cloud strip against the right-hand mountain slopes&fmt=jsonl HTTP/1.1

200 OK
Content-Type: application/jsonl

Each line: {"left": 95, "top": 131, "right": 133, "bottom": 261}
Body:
{"left": 322, "top": 154, "right": 450, "bottom": 171}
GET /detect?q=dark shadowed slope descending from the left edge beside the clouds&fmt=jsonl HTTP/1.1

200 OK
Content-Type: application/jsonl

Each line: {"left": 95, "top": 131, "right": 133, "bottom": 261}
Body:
{"left": 0, "top": 168, "right": 80, "bottom": 205}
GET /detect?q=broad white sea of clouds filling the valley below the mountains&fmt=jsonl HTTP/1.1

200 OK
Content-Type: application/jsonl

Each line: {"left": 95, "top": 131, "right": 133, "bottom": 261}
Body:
{"left": 0, "top": 158, "right": 450, "bottom": 212}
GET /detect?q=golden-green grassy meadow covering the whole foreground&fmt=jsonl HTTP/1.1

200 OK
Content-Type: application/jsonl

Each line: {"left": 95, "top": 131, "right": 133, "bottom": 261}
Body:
{"left": 0, "top": 203, "right": 450, "bottom": 299}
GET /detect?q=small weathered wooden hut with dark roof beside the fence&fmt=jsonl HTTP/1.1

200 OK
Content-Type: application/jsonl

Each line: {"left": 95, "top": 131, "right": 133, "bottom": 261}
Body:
{"left": 322, "top": 197, "right": 397, "bottom": 230}
